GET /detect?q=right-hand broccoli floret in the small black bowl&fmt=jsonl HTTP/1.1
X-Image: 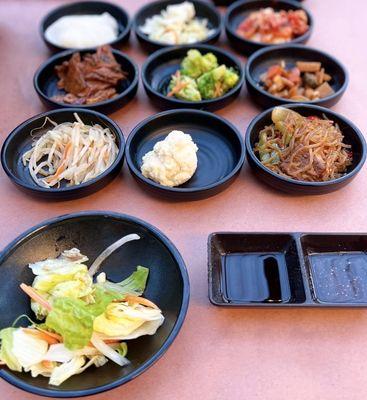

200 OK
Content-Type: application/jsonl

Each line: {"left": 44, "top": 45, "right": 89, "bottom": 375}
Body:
{"left": 197, "top": 65, "right": 239, "bottom": 99}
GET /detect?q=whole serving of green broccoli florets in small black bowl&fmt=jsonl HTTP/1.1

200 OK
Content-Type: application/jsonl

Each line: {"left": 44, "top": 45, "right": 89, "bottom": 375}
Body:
{"left": 167, "top": 49, "right": 240, "bottom": 102}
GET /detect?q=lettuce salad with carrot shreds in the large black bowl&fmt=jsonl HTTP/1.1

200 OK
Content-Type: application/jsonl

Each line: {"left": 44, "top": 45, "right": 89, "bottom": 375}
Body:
{"left": 0, "top": 234, "right": 164, "bottom": 386}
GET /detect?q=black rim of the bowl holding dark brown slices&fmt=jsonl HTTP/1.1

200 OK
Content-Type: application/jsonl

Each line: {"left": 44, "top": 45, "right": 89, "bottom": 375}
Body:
{"left": 33, "top": 48, "right": 139, "bottom": 110}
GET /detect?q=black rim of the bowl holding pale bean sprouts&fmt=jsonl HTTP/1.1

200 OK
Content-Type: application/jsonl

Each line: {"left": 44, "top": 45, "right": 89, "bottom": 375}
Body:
{"left": 0, "top": 107, "right": 126, "bottom": 196}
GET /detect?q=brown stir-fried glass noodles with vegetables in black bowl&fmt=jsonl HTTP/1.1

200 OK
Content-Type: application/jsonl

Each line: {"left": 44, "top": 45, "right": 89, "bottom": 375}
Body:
{"left": 254, "top": 107, "right": 352, "bottom": 182}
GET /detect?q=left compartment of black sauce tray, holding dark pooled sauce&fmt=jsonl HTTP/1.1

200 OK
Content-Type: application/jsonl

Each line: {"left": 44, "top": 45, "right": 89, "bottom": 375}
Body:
{"left": 209, "top": 233, "right": 306, "bottom": 306}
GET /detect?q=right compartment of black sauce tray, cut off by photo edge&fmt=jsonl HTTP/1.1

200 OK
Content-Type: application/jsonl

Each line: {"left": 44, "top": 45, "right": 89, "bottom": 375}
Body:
{"left": 301, "top": 234, "right": 367, "bottom": 305}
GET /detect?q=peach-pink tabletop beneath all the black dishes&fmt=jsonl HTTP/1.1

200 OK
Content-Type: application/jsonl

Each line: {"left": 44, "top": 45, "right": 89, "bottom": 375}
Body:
{"left": 0, "top": 0, "right": 367, "bottom": 400}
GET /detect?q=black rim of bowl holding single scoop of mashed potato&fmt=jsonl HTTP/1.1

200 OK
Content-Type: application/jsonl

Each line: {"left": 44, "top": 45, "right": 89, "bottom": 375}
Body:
{"left": 126, "top": 108, "right": 246, "bottom": 195}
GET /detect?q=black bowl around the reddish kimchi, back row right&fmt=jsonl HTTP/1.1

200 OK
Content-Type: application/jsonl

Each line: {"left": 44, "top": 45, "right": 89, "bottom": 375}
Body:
{"left": 224, "top": 0, "right": 313, "bottom": 55}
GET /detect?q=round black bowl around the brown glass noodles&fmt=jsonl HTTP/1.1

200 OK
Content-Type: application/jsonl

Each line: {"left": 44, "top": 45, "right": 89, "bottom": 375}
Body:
{"left": 245, "top": 104, "right": 367, "bottom": 195}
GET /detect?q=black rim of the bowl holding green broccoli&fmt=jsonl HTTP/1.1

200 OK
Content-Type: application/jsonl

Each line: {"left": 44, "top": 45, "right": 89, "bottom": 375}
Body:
{"left": 141, "top": 44, "right": 245, "bottom": 107}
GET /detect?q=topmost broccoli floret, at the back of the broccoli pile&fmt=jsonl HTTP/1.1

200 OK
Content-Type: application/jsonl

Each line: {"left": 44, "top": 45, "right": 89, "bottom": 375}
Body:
{"left": 181, "top": 50, "right": 218, "bottom": 79}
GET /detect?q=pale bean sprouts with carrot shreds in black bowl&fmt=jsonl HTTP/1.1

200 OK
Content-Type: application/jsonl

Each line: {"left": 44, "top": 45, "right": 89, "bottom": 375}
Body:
{"left": 22, "top": 114, "right": 118, "bottom": 188}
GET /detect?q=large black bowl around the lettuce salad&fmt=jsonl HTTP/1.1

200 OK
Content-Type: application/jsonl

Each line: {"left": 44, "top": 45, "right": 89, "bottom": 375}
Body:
{"left": 0, "top": 211, "right": 190, "bottom": 398}
